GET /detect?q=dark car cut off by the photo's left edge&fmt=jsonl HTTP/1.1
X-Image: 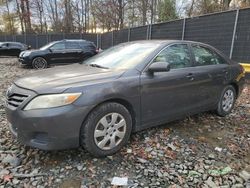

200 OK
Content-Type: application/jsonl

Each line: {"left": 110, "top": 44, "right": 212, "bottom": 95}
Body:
{"left": 0, "top": 42, "right": 29, "bottom": 57}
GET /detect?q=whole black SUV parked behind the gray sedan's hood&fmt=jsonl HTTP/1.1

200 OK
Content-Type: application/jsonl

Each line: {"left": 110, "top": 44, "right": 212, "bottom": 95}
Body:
{"left": 19, "top": 40, "right": 98, "bottom": 69}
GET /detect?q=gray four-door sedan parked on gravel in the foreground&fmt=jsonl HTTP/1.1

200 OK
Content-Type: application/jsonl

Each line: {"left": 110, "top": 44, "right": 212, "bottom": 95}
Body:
{"left": 5, "top": 40, "right": 244, "bottom": 157}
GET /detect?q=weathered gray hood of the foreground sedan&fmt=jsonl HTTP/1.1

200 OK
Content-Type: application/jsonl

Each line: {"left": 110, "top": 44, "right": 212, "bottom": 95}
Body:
{"left": 14, "top": 64, "right": 124, "bottom": 94}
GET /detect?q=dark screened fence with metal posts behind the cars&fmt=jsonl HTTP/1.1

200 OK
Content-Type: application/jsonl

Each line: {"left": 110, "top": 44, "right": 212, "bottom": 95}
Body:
{"left": 0, "top": 8, "right": 250, "bottom": 62}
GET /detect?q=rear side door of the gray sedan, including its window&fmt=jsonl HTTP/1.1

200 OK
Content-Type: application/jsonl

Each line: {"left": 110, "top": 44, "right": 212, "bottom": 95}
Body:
{"left": 191, "top": 44, "right": 230, "bottom": 106}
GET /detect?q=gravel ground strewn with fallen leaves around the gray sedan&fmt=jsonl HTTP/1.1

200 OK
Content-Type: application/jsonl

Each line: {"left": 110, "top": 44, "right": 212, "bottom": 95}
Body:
{"left": 0, "top": 58, "right": 250, "bottom": 188}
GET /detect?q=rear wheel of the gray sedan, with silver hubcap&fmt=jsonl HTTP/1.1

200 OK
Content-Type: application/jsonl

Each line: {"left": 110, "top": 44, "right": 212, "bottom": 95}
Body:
{"left": 216, "top": 85, "right": 236, "bottom": 117}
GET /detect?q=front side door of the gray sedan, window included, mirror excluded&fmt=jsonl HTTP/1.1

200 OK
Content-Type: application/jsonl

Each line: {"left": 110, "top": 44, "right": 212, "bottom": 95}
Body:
{"left": 141, "top": 43, "right": 203, "bottom": 126}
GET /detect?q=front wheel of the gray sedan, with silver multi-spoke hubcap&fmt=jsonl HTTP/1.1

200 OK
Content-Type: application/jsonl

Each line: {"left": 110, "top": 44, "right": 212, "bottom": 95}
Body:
{"left": 80, "top": 102, "right": 132, "bottom": 157}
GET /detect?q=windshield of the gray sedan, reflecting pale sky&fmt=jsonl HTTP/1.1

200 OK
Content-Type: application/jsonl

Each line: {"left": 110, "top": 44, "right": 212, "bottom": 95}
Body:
{"left": 83, "top": 43, "right": 159, "bottom": 69}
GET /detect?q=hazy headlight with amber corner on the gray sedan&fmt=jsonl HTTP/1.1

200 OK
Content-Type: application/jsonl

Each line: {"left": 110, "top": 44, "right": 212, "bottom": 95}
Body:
{"left": 24, "top": 93, "right": 81, "bottom": 110}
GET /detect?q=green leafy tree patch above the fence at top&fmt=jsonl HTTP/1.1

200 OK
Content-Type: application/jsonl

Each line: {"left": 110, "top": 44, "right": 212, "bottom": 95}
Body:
{"left": 158, "top": 0, "right": 178, "bottom": 22}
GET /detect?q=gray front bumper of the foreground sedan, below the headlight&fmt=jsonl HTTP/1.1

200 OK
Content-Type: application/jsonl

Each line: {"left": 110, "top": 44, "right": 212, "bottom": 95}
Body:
{"left": 5, "top": 84, "right": 91, "bottom": 150}
